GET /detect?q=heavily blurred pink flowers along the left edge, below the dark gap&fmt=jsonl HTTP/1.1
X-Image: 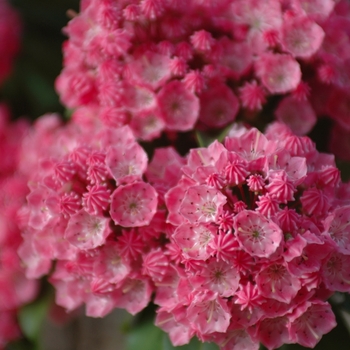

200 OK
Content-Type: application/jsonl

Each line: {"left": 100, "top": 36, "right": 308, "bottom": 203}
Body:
{"left": 0, "top": 105, "right": 37, "bottom": 349}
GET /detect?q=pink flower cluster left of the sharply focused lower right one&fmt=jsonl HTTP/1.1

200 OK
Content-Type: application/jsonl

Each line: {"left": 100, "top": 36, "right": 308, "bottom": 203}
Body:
{"left": 19, "top": 115, "right": 178, "bottom": 317}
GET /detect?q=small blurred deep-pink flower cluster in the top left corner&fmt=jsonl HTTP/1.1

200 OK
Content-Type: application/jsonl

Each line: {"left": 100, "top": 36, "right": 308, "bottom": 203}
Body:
{"left": 0, "top": 0, "right": 21, "bottom": 85}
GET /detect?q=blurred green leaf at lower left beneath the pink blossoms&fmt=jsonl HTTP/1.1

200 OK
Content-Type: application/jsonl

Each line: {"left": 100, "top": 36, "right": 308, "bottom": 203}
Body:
{"left": 18, "top": 297, "right": 50, "bottom": 342}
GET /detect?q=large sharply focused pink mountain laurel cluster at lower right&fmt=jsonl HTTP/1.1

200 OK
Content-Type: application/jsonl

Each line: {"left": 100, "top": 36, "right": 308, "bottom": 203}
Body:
{"left": 155, "top": 122, "right": 350, "bottom": 350}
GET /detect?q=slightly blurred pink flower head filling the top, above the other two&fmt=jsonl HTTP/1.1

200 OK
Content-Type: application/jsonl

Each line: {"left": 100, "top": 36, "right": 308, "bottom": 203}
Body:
{"left": 56, "top": 0, "right": 350, "bottom": 141}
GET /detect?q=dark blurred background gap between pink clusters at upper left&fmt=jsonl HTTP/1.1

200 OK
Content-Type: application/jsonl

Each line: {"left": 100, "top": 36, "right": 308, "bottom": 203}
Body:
{"left": 1, "top": 0, "right": 79, "bottom": 120}
